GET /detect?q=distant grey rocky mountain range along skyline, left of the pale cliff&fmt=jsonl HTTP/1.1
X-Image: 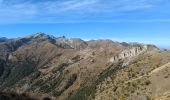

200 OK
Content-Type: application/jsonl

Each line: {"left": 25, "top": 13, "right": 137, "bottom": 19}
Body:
{"left": 0, "top": 33, "right": 127, "bottom": 50}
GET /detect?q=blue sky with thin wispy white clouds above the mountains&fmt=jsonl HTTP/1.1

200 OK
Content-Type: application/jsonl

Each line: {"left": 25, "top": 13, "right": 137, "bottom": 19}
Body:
{"left": 0, "top": 0, "right": 170, "bottom": 47}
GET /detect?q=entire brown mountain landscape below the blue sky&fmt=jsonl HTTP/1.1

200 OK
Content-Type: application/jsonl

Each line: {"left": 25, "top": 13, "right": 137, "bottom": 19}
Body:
{"left": 0, "top": 33, "right": 170, "bottom": 100}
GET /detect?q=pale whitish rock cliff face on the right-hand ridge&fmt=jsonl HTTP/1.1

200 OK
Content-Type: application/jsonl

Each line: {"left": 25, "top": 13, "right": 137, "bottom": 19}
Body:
{"left": 110, "top": 45, "right": 148, "bottom": 62}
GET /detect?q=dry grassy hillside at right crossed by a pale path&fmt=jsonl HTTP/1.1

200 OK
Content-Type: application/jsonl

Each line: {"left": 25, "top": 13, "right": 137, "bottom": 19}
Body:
{"left": 94, "top": 51, "right": 170, "bottom": 100}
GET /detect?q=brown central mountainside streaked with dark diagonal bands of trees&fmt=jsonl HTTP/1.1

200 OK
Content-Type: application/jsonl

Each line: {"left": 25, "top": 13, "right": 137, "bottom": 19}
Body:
{"left": 3, "top": 47, "right": 119, "bottom": 99}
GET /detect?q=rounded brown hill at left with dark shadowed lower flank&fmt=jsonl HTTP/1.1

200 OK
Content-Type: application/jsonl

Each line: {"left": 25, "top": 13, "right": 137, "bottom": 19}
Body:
{"left": 0, "top": 42, "right": 63, "bottom": 88}
